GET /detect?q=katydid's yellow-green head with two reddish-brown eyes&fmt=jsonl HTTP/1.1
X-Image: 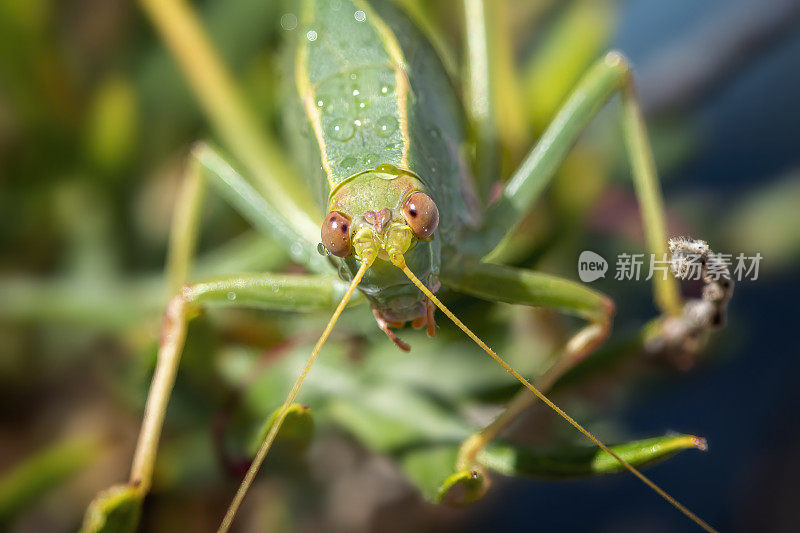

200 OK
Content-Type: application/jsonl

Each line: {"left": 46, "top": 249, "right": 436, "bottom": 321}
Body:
{"left": 321, "top": 165, "right": 441, "bottom": 324}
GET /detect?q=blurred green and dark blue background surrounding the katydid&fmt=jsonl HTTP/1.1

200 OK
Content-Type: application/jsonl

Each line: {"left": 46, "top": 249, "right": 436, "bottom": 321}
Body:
{"left": 0, "top": 0, "right": 800, "bottom": 532}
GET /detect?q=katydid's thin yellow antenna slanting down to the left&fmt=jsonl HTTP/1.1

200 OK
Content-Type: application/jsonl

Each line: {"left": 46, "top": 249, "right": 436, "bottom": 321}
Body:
{"left": 217, "top": 254, "right": 375, "bottom": 533}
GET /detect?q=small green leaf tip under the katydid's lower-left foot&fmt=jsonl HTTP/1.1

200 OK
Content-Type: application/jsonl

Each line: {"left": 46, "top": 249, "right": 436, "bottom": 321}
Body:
{"left": 81, "top": 485, "right": 144, "bottom": 533}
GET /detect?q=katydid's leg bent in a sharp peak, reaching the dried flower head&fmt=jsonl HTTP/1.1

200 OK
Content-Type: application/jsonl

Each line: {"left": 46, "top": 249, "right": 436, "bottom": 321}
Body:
{"left": 472, "top": 52, "right": 682, "bottom": 315}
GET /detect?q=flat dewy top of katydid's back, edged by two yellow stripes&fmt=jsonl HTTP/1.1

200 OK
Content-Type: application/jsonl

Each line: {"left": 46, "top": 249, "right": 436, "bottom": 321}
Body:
{"left": 296, "top": 1, "right": 409, "bottom": 188}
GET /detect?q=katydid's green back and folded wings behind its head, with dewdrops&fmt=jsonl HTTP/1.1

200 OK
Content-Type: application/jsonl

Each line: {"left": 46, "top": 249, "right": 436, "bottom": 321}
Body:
{"left": 290, "top": 0, "right": 482, "bottom": 245}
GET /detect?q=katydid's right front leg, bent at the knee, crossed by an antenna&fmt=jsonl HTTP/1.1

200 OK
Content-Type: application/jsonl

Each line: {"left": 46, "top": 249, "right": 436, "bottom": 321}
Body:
{"left": 441, "top": 261, "right": 614, "bottom": 470}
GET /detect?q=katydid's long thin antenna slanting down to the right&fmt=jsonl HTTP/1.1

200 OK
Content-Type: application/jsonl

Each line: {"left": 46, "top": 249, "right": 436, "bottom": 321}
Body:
{"left": 392, "top": 254, "right": 716, "bottom": 532}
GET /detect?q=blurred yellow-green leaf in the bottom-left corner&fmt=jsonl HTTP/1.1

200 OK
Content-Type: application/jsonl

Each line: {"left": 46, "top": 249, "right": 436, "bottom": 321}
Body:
{"left": 0, "top": 437, "right": 100, "bottom": 522}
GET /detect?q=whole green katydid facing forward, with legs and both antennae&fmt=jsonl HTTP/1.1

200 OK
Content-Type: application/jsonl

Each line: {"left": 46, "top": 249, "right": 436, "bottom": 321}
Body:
{"left": 83, "top": 0, "right": 732, "bottom": 530}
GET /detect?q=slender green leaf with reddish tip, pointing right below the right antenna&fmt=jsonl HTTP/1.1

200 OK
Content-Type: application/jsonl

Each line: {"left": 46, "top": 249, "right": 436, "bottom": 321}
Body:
{"left": 478, "top": 435, "right": 706, "bottom": 479}
